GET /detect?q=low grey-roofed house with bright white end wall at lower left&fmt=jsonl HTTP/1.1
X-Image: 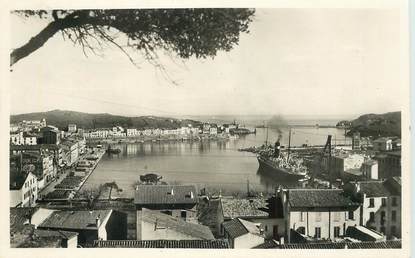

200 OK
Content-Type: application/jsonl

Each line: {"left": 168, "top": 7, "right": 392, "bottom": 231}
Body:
{"left": 37, "top": 210, "right": 127, "bottom": 246}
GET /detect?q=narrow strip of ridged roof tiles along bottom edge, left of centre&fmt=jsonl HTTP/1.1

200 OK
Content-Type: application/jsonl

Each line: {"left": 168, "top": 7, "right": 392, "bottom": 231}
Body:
{"left": 94, "top": 239, "right": 229, "bottom": 249}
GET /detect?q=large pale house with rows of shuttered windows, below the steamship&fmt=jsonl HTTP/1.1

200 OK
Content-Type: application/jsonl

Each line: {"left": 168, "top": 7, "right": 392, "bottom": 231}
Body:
{"left": 277, "top": 189, "right": 360, "bottom": 243}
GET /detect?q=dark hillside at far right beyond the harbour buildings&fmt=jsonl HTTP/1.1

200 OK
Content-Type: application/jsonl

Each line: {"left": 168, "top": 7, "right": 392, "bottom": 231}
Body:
{"left": 348, "top": 112, "right": 401, "bottom": 137}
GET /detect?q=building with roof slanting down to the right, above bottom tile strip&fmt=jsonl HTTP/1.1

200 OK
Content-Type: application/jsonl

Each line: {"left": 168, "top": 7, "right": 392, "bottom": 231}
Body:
{"left": 136, "top": 208, "right": 215, "bottom": 240}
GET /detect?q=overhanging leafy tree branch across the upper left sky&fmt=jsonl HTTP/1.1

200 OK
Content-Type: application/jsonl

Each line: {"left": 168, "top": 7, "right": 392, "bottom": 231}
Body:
{"left": 10, "top": 9, "right": 254, "bottom": 73}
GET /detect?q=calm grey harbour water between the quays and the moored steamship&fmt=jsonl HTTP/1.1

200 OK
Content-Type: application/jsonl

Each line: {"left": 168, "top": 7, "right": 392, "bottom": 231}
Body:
{"left": 84, "top": 125, "right": 349, "bottom": 197}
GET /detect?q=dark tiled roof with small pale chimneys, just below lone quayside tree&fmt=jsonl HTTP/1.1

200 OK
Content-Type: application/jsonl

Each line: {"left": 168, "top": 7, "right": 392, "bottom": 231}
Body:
{"left": 134, "top": 185, "right": 197, "bottom": 204}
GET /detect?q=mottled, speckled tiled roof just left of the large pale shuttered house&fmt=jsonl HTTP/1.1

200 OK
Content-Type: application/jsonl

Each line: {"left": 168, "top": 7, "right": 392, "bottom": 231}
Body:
{"left": 221, "top": 198, "right": 268, "bottom": 219}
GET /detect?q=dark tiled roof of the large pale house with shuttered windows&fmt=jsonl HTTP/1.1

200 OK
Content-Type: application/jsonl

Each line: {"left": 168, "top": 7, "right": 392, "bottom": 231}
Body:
{"left": 288, "top": 189, "right": 359, "bottom": 209}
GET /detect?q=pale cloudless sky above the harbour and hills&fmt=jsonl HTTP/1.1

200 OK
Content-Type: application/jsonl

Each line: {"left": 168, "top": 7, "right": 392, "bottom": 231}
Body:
{"left": 10, "top": 8, "right": 407, "bottom": 117}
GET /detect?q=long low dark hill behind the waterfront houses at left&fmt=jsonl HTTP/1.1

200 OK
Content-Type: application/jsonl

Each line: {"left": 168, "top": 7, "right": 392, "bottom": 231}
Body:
{"left": 10, "top": 110, "right": 201, "bottom": 130}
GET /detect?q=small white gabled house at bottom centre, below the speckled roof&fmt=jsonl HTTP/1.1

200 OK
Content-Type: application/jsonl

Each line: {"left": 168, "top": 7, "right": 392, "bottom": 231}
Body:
{"left": 223, "top": 218, "right": 265, "bottom": 249}
